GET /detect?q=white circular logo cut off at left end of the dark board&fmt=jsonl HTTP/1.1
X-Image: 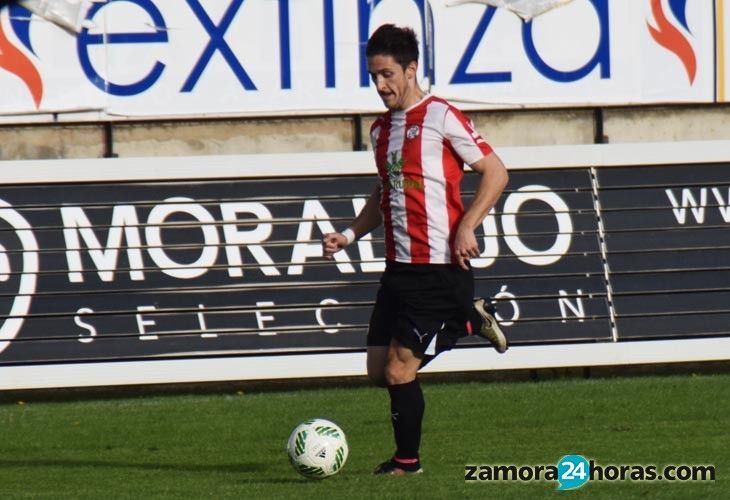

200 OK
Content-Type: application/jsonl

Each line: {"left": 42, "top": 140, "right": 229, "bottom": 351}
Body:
{"left": 0, "top": 200, "right": 38, "bottom": 352}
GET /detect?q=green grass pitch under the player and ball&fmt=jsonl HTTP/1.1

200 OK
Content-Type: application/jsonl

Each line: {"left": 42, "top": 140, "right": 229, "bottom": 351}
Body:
{"left": 0, "top": 374, "right": 730, "bottom": 500}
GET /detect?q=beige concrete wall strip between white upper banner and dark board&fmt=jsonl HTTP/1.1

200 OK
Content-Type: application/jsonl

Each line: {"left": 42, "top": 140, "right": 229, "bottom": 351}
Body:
{"left": 0, "top": 105, "right": 730, "bottom": 160}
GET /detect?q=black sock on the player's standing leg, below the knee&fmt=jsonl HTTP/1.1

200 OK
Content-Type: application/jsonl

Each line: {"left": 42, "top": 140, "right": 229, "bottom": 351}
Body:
{"left": 388, "top": 379, "right": 426, "bottom": 460}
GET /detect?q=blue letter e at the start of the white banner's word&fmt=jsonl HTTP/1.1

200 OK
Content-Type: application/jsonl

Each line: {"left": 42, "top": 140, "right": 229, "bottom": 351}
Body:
{"left": 76, "top": 0, "right": 167, "bottom": 96}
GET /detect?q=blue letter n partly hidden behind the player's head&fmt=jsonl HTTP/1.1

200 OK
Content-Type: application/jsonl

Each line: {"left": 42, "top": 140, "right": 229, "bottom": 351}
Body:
{"left": 358, "top": 0, "right": 436, "bottom": 87}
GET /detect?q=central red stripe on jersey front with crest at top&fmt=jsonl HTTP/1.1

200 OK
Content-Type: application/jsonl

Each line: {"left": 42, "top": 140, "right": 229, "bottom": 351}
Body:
{"left": 402, "top": 106, "right": 431, "bottom": 264}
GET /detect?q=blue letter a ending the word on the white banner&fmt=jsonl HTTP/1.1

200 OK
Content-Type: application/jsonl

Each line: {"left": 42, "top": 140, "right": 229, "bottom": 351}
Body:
{"left": 522, "top": 0, "right": 611, "bottom": 82}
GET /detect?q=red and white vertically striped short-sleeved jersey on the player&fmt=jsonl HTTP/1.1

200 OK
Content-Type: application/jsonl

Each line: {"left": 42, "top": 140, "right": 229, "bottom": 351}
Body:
{"left": 370, "top": 95, "right": 492, "bottom": 264}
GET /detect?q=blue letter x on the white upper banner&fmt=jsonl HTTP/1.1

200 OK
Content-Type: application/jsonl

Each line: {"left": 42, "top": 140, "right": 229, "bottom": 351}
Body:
{"left": 180, "top": 0, "right": 256, "bottom": 92}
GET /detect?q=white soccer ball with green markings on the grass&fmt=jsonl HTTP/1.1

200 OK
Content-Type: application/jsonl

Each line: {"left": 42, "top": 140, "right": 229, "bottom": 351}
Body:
{"left": 286, "top": 418, "right": 349, "bottom": 479}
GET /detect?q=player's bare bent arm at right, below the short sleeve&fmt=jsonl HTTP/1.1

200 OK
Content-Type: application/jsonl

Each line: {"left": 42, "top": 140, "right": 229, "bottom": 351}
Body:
{"left": 454, "top": 151, "right": 509, "bottom": 270}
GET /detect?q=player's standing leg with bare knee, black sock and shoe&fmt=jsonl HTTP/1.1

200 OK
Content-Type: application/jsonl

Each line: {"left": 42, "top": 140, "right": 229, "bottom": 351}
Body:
{"left": 375, "top": 339, "right": 425, "bottom": 476}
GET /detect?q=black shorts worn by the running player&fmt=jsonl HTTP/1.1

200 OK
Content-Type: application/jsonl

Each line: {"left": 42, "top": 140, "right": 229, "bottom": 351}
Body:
{"left": 367, "top": 261, "right": 474, "bottom": 361}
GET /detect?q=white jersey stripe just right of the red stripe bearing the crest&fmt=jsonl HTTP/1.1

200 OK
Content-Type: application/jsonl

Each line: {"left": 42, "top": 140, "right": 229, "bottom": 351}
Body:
{"left": 421, "top": 101, "right": 451, "bottom": 263}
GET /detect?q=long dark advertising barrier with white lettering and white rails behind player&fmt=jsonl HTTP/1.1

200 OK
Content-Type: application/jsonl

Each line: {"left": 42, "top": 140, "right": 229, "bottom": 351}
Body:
{"left": 0, "top": 141, "right": 730, "bottom": 389}
